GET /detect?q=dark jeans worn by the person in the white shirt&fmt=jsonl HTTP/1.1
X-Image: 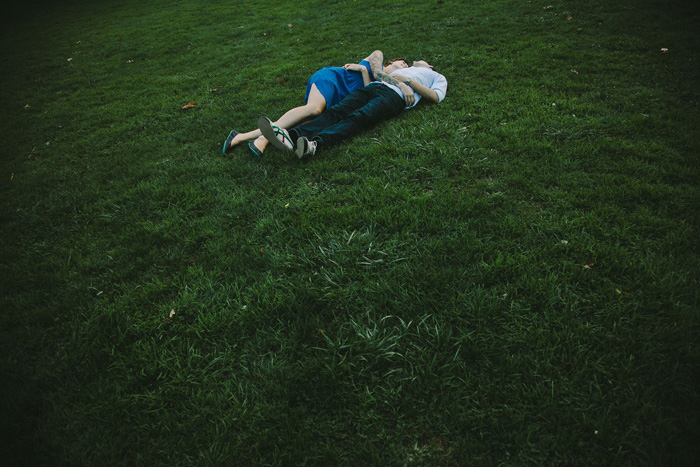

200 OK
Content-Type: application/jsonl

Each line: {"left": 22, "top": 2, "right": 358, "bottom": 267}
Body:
{"left": 289, "top": 83, "right": 406, "bottom": 146}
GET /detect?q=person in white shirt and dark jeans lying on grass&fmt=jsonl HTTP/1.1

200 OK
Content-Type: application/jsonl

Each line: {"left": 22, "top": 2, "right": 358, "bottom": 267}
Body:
{"left": 258, "top": 60, "right": 447, "bottom": 158}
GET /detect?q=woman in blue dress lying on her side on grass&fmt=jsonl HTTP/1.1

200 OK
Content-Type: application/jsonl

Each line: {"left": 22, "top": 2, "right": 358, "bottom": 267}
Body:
{"left": 221, "top": 50, "right": 408, "bottom": 157}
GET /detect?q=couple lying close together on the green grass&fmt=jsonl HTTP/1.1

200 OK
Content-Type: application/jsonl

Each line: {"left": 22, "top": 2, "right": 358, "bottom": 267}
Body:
{"left": 222, "top": 50, "right": 447, "bottom": 158}
